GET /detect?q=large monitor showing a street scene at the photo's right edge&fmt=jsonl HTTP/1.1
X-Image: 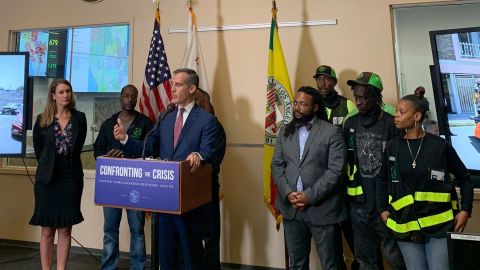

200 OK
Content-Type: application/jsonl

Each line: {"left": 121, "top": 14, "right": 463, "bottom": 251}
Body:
{"left": 430, "top": 27, "right": 480, "bottom": 175}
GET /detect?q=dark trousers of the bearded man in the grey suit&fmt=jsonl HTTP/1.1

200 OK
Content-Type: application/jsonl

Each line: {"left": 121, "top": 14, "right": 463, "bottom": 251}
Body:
{"left": 283, "top": 211, "right": 343, "bottom": 270}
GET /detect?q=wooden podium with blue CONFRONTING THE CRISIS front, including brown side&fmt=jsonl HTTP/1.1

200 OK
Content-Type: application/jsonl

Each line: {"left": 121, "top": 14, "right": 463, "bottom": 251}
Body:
{"left": 94, "top": 157, "right": 212, "bottom": 215}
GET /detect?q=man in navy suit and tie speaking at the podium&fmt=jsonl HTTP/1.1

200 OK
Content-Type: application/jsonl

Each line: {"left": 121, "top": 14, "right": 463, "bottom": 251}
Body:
{"left": 113, "top": 68, "right": 217, "bottom": 270}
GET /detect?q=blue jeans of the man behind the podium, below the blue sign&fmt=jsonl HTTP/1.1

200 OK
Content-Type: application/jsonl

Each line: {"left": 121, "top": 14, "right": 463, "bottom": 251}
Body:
{"left": 100, "top": 207, "right": 147, "bottom": 270}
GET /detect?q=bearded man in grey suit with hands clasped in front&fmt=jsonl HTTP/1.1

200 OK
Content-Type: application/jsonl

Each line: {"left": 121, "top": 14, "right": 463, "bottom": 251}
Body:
{"left": 271, "top": 86, "right": 346, "bottom": 270}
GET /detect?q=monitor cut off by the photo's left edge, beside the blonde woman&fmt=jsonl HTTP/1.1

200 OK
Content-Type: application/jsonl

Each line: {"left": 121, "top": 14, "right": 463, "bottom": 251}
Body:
{"left": 0, "top": 52, "right": 29, "bottom": 157}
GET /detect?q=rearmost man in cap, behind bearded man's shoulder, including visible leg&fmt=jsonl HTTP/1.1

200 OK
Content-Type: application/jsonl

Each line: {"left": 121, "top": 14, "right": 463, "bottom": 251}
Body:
{"left": 313, "top": 65, "right": 358, "bottom": 270}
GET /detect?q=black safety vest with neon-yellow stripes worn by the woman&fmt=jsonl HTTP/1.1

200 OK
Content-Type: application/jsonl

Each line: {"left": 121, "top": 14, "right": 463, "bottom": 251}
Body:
{"left": 386, "top": 135, "right": 458, "bottom": 242}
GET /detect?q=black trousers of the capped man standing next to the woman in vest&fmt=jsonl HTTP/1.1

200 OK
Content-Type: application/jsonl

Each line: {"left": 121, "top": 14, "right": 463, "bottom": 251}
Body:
{"left": 350, "top": 202, "right": 406, "bottom": 270}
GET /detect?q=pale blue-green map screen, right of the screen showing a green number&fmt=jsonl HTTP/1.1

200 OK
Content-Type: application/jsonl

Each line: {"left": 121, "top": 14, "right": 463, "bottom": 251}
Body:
{"left": 65, "top": 25, "right": 129, "bottom": 92}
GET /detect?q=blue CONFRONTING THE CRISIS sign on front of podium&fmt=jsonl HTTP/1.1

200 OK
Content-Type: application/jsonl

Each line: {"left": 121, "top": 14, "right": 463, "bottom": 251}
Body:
{"left": 95, "top": 157, "right": 180, "bottom": 212}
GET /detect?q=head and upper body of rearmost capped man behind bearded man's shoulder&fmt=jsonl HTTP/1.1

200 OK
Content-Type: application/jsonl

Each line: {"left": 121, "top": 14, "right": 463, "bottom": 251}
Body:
{"left": 313, "top": 65, "right": 355, "bottom": 127}
